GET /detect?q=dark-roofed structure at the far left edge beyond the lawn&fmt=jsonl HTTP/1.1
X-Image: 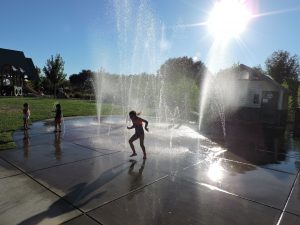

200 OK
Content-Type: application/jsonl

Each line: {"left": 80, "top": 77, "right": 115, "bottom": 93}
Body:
{"left": 0, "top": 48, "right": 38, "bottom": 96}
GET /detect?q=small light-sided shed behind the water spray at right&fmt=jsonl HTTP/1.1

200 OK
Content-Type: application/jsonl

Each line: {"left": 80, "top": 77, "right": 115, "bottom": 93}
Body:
{"left": 217, "top": 64, "right": 289, "bottom": 126}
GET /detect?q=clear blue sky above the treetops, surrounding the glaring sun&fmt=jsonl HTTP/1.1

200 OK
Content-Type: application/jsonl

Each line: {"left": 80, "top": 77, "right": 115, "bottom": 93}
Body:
{"left": 0, "top": 0, "right": 300, "bottom": 75}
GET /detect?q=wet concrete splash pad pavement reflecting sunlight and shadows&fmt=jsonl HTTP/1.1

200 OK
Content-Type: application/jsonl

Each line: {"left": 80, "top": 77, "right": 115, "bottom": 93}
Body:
{"left": 0, "top": 117, "right": 300, "bottom": 225}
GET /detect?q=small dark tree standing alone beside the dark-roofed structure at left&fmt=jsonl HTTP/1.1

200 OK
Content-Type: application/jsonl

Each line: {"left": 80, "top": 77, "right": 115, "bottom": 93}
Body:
{"left": 43, "top": 54, "right": 66, "bottom": 97}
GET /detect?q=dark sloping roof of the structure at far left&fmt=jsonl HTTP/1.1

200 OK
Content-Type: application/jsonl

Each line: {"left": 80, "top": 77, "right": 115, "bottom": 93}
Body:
{"left": 0, "top": 48, "right": 38, "bottom": 80}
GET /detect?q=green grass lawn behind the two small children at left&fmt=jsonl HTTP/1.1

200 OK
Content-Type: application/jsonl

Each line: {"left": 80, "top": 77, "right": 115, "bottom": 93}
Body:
{"left": 0, "top": 97, "right": 121, "bottom": 150}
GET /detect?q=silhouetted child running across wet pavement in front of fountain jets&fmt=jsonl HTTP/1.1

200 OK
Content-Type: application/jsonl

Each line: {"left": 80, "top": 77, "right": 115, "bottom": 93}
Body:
{"left": 127, "top": 111, "right": 149, "bottom": 159}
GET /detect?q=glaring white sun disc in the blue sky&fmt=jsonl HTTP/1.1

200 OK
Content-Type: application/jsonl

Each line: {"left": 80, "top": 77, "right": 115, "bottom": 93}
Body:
{"left": 207, "top": 0, "right": 252, "bottom": 40}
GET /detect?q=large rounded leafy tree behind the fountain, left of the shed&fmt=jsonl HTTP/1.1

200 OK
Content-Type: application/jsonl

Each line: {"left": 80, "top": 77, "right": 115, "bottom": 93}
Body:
{"left": 159, "top": 57, "right": 207, "bottom": 119}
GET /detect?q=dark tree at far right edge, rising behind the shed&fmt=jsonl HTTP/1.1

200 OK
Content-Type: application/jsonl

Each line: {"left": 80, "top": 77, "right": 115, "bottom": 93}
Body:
{"left": 266, "top": 51, "right": 300, "bottom": 110}
